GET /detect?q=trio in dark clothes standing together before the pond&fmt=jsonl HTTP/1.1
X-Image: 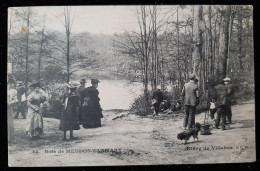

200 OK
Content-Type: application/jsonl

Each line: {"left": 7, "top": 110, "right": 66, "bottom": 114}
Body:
{"left": 59, "top": 79, "right": 103, "bottom": 140}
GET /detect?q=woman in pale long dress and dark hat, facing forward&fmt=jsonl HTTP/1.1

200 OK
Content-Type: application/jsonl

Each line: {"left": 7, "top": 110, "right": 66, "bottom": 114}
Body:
{"left": 26, "top": 82, "right": 46, "bottom": 139}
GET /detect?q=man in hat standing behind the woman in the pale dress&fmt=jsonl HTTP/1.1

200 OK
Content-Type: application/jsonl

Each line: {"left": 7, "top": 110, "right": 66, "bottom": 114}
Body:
{"left": 14, "top": 81, "right": 27, "bottom": 119}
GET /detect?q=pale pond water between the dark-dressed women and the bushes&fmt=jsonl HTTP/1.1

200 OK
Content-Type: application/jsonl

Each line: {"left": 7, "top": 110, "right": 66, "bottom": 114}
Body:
{"left": 81, "top": 80, "right": 143, "bottom": 110}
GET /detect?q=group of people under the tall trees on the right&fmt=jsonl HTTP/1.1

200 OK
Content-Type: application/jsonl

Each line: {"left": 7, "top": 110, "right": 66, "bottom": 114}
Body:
{"left": 152, "top": 74, "right": 234, "bottom": 130}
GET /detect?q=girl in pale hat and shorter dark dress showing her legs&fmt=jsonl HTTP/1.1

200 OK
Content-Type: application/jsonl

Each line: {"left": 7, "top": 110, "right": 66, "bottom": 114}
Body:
{"left": 59, "top": 83, "right": 80, "bottom": 140}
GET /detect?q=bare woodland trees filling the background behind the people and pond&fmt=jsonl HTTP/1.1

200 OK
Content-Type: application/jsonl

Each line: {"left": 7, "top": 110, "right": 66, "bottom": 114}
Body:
{"left": 8, "top": 5, "right": 254, "bottom": 116}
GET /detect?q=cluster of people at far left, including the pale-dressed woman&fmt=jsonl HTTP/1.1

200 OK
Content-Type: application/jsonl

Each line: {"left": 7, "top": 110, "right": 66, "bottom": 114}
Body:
{"left": 8, "top": 80, "right": 47, "bottom": 140}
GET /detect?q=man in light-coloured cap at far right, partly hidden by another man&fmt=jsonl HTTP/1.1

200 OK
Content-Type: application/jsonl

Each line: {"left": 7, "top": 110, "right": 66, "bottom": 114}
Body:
{"left": 223, "top": 77, "right": 234, "bottom": 124}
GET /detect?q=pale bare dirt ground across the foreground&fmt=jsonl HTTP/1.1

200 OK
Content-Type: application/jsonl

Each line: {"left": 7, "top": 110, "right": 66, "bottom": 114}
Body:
{"left": 8, "top": 101, "right": 256, "bottom": 166}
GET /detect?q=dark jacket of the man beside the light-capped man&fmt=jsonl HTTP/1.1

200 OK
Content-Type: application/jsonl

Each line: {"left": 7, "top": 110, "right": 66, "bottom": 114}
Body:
{"left": 214, "top": 84, "right": 227, "bottom": 107}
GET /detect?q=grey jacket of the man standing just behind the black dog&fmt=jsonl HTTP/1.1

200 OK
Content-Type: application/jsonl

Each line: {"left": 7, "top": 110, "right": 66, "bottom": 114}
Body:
{"left": 181, "top": 80, "right": 199, "bottom": 106}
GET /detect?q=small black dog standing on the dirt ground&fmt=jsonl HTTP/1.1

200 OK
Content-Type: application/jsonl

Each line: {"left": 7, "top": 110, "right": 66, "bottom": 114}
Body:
{"left": 177, "top": 123, "right": 201, "bottom": 144}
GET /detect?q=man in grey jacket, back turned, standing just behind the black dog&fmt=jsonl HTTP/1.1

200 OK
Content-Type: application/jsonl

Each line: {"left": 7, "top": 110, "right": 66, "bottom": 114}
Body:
{"left": 181, "top": 74, "right": 199, "bottom": 129}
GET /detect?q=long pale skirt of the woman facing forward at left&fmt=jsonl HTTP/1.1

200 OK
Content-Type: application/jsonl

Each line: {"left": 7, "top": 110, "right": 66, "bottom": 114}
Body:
{"left": 26, "top": 108, "right": 43, "bottom": 137}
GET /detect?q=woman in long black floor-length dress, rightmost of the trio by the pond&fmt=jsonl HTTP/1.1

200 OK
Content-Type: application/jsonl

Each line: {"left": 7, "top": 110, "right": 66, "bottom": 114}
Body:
{"left": 82, "top": 79, "right": 103, "bottom": 128}
